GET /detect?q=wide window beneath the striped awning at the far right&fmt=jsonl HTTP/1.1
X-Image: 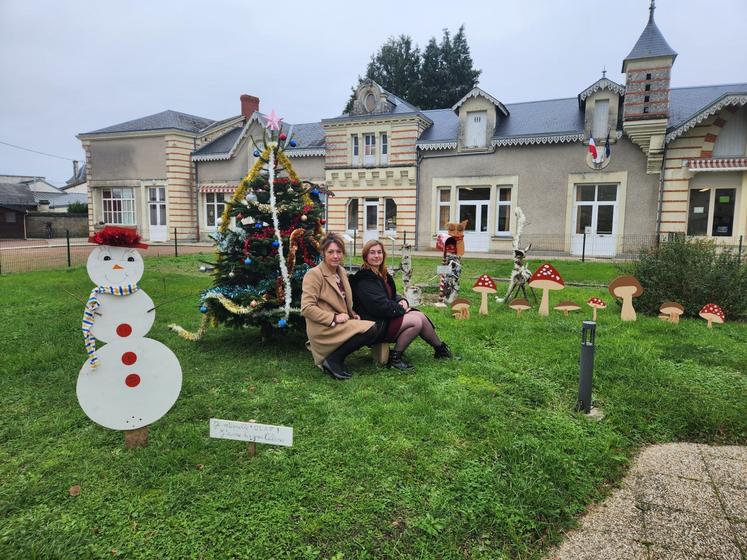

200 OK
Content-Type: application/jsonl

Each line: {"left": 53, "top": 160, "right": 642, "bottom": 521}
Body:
{"left": 687, "top": 188, "right": 737, "bottom": 237}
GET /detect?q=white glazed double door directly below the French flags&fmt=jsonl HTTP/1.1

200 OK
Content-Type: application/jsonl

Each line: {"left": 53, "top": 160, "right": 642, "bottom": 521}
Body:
{"left": 571, "top": 185, "right": 617, "bottom": 257}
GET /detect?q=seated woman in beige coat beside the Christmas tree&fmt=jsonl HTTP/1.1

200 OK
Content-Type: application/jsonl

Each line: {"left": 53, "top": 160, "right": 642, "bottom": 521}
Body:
{"left": 301, "top": 233, "right": 379, "bottom": 380}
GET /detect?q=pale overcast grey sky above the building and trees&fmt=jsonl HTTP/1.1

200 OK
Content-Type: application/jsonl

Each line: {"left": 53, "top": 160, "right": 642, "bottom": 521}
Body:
{"left": 0, "top": 0, "right": 747, "bottom": 186}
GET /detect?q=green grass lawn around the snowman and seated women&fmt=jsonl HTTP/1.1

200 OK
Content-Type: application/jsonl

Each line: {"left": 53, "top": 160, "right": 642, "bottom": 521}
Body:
{"left": 0, "top": 255, "right": 747, "bottom": 560}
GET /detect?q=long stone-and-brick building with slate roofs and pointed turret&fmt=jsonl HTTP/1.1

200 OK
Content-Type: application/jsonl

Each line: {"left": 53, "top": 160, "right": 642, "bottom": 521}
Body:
{"left": 79, "top": 5, "right": 747, "bottom": 256}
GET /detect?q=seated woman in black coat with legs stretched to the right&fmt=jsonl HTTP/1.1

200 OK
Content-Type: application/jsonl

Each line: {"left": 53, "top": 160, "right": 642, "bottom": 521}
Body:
{"left": 350, "top": 240, "right": 451, "bottom": 370}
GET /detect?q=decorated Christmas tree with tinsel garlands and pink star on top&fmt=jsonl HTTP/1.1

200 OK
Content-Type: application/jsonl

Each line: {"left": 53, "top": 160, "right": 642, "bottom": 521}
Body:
{"left": 171, "top": 110, "right": 325, "bottom": 340}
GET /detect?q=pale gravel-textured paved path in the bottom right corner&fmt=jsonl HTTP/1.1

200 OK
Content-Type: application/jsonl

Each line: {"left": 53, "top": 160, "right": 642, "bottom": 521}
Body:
{"left": 547, "top": 443, "right": 747, "bottom": 560}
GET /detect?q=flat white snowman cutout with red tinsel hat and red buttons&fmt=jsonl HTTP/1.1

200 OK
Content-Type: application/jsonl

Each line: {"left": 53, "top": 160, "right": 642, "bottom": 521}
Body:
{"left": 77, "top": 226, "right": 182, "bottom": 430}
